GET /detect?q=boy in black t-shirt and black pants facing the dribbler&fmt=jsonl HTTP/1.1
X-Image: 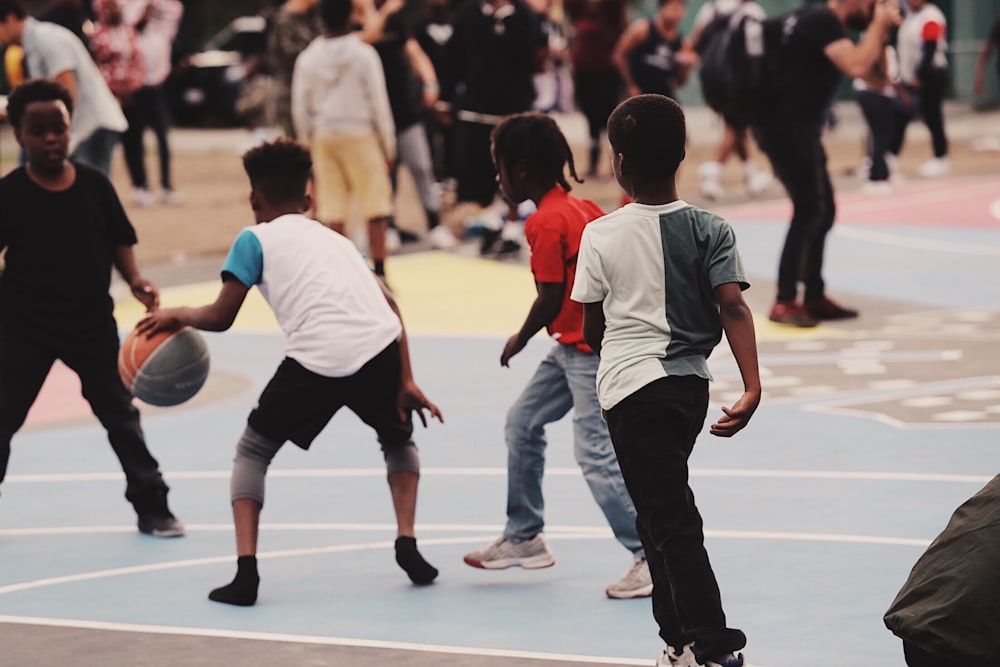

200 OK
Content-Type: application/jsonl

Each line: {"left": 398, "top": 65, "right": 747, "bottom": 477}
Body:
{"left": 0, "top": 79, "right": 184, "bottom": 537}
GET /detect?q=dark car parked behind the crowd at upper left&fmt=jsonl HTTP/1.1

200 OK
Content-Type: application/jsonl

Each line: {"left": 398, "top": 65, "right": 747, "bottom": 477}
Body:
{"left": 167, "top": 16, "right": 267, "bottom": 126}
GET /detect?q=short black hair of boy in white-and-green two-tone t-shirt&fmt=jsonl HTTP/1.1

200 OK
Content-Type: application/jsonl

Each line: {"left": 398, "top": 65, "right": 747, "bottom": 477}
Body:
{"left": 608, "top": 95, "right": 687, "bottom": 179}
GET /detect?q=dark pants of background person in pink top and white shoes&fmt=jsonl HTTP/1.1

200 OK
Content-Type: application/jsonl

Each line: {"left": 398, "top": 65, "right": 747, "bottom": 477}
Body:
{"left": 122, "top": 86, "right": 173, "bottom": 190}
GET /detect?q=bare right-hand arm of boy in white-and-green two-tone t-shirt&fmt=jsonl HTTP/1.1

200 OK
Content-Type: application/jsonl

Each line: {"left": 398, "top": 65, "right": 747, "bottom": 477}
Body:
{"left": 711, "top": 283, "right": 761, "bottom": 438}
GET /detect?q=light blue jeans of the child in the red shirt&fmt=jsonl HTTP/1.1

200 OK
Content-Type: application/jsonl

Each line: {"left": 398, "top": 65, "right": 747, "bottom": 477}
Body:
{"left": 504, "top": 345, "right": 643, "bottom": 555}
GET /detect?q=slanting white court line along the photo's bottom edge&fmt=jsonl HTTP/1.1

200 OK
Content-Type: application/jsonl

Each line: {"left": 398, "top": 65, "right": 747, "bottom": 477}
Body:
{"left": 0, "top": 616, "right": 650, "bottom": 665}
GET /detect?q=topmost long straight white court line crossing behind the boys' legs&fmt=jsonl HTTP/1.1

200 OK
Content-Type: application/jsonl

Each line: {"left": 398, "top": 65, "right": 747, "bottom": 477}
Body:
{"left": 5, "top": 468, "right": 993, "bottom": 484}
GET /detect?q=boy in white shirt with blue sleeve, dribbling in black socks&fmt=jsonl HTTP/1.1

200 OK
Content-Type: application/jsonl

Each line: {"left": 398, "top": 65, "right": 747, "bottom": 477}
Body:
{"left": 137, "top": 138, "right": 444, "bottom": 606}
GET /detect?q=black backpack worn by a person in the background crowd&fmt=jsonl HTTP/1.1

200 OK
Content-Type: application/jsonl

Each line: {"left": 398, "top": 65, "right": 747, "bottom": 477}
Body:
{"left": 695, "top": 2, "right": 777, "bottom": 125}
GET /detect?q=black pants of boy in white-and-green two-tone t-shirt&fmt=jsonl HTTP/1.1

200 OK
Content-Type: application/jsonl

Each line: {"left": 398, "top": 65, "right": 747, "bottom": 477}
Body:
{"left": 605, "top": 376, "right": 746, "bottom": 659}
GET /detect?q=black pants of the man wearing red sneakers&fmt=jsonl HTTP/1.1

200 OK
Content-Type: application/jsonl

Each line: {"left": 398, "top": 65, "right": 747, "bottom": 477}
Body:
{"left": 753, "top": 122, "right": 837, "bottom": 301}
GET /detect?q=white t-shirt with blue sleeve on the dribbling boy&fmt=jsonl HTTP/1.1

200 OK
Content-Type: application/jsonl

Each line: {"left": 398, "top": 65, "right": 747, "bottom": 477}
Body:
{"left": 222, "top": 214, "right": 403, "bottom": 377}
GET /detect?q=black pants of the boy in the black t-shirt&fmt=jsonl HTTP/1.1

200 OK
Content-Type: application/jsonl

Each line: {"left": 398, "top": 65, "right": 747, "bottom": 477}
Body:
{"left": 0, "top": 326, "right": 167, "bottom": 513}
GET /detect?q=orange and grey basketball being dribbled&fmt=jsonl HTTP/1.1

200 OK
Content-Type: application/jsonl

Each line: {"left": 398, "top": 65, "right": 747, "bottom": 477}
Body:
{"left": 118, "top": 327, "right": 208, "bottom": 407}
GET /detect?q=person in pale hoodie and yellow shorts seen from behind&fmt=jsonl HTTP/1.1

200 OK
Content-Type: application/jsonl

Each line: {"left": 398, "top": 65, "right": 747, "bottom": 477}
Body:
{"left": 292, "top": 0, "right": 396, "bottom": 278}
